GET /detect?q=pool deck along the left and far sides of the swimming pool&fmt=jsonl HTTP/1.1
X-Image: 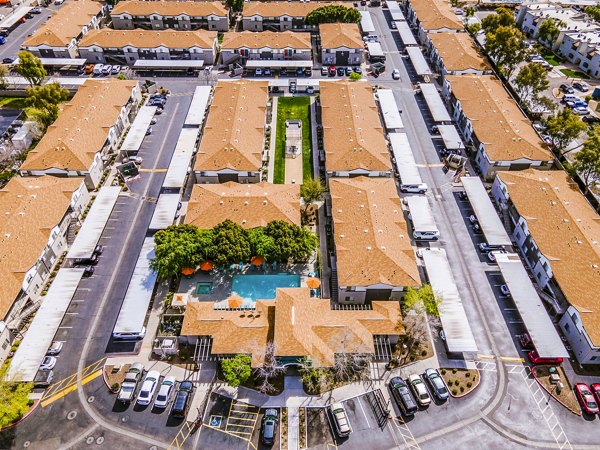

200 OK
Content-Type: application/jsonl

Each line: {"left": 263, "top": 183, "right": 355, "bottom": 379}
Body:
{"left": 177, "top": 261, "right": 315, "bottom": 305}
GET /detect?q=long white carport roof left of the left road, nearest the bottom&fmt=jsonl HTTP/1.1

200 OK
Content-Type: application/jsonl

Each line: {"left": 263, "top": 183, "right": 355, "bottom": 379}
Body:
{"left": 7, "top": 269, "right": 83, "bottom": 382}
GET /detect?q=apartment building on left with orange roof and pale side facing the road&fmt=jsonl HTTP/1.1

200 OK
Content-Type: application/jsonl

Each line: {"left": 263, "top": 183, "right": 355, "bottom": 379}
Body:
{"left": 19, "top": 78, "right": 142, "bottom": 190}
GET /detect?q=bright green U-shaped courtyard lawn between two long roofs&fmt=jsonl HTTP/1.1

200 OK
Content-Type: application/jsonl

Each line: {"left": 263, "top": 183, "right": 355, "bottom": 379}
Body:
{"left": 273, "top": 97, "right": 313, "bottom": 184}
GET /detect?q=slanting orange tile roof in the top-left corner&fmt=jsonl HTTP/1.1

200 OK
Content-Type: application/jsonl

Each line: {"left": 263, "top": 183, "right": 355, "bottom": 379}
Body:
{"left": 22, "top": 0, "right": 103, "bottom": 47}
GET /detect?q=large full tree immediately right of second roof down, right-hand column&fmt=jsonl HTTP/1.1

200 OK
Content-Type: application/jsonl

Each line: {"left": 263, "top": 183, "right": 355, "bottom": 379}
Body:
{"left": 485, "top": 26, "right": 527, "bottom": 78}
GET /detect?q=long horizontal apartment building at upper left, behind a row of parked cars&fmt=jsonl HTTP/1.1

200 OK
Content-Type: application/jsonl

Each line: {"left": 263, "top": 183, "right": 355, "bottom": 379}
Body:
{"left": 79, "top": 28, "right": 217, "bottom": 66}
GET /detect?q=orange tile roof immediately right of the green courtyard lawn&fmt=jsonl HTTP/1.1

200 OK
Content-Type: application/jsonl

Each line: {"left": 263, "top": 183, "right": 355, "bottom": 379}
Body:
{"left": 320, "top": 81, "right": 391, "bottom": 171}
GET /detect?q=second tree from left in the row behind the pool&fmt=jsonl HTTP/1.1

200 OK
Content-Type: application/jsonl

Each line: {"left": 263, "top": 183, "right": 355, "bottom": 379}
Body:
{"left": 211, "top": 219, "right": 252, "bottom": 266}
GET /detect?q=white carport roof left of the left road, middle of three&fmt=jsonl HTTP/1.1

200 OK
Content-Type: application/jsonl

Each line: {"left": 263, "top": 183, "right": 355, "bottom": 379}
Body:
{"left": 67, "top": 186, "right": 121, "bottom": 258}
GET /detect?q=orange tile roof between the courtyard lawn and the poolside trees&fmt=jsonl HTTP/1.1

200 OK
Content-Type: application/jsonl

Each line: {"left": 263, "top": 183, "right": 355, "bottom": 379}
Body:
{"left": 185, "top": 181, "right": 300, "bottom": 228}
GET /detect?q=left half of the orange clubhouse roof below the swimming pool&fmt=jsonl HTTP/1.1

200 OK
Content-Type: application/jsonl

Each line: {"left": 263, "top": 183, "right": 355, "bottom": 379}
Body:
{"left": 181, "top": 300, "right": 275, "bottom": 367}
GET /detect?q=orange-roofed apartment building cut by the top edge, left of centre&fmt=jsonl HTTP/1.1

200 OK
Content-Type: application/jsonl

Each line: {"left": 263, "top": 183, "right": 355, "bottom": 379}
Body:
{"left": 110, "top": 1, "right": 229, "bottom": 31}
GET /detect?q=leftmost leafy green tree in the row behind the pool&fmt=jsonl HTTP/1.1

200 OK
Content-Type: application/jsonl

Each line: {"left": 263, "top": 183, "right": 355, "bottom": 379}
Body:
{"left": 150, "top": 224, "right": 212, "bottom": 278}
